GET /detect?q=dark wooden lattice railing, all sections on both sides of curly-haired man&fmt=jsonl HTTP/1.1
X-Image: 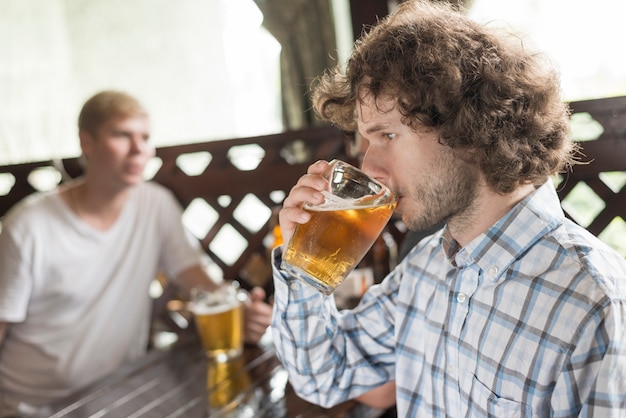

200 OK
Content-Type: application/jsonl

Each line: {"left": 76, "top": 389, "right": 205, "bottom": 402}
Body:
{"left": 0, "top": 97, "right": 626, "bottom": 294}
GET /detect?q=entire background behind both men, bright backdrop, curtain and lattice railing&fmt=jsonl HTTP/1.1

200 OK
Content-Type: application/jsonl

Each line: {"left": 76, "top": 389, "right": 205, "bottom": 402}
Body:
{"left": 0, "top": 0, "right": 626, "bottom": 264}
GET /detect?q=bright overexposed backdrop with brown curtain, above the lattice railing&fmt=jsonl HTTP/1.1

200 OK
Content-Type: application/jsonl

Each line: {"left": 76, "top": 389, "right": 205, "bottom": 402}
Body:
{"left": 0, "top": 0, "right": 626, "bottom": 165}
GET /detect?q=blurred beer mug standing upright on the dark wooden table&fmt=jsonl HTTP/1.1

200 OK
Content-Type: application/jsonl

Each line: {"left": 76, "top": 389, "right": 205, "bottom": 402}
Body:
{"left": 191, "top": 283, "right": 247, "bottom": 362}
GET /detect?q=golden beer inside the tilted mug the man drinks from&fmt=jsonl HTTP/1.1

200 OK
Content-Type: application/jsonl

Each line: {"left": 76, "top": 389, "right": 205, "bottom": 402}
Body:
{"left": 282, "top": 200, "right": 396, "bottom": 294}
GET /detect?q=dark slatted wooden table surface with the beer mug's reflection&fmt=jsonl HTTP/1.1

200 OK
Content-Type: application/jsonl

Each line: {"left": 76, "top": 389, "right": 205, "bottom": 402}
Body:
{"left": 31, "top": 338, "right": 383, "bottom": 418}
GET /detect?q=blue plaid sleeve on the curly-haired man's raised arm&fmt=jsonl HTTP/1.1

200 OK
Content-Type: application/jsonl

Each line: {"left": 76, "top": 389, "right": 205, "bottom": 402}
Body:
{"left": 272, "top": 247, "right": 397, "bottom": 407}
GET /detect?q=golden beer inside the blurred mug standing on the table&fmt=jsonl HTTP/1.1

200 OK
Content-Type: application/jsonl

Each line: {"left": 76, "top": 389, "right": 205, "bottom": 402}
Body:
{"left": 193, "top": 300, "right": 244, "bottom": 361}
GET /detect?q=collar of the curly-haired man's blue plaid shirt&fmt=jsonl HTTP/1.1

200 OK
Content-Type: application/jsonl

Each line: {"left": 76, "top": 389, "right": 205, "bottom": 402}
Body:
{"left": 442, "top": 180, "right": 564, "bottom": 282}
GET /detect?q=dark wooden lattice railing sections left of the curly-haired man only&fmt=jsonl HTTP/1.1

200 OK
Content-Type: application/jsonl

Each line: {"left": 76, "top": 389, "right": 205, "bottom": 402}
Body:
{"left": 0, "top": 126, "right": 356, "bottom": 290}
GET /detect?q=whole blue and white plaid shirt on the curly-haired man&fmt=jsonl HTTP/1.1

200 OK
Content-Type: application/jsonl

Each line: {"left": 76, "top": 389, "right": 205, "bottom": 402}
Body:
{"left": 272, "top": 182, "right": 626, "bottom": 417}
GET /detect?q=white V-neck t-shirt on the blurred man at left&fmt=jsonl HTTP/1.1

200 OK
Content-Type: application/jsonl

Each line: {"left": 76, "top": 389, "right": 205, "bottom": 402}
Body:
{"left": 0, "top": 183, "right": 201, "bottom": 411}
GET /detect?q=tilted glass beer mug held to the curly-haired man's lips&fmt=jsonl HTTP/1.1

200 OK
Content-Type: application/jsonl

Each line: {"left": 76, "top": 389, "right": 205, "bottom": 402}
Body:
{"left": 281, "top": 160, "right": 396, "bottom": 295}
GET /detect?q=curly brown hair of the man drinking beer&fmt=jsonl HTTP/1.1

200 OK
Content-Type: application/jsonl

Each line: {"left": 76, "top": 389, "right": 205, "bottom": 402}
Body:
{"left": 313, "top": 0, "right": 575, "bottom": 193}
